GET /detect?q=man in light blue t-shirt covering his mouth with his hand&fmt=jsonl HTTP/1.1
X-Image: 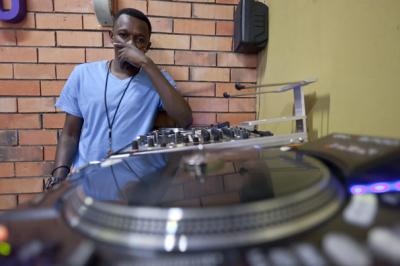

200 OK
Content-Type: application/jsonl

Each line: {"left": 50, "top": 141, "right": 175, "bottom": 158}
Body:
{"left": 46, "top": 8, "right": 192, "bottom": 188}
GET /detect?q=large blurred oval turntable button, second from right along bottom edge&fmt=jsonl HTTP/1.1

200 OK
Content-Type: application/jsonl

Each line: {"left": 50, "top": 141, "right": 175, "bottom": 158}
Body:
{"left": 322, "top": 233, "right": 372, "bottom": 266}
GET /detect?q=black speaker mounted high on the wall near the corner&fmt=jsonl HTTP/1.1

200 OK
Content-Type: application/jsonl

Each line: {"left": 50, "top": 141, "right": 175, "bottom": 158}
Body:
{"left": 233, "top": 0, "right": 268, "bottom": 53}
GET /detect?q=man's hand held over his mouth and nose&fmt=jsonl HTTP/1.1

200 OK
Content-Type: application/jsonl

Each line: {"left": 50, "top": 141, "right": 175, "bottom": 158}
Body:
{"left": 113, "top": 42, "right": 149, "bottom": 68}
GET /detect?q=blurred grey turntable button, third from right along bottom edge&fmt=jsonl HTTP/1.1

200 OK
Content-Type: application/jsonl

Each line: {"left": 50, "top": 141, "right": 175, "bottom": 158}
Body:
{"left": 293, "top": 243, "right": 328, "bottom": 266}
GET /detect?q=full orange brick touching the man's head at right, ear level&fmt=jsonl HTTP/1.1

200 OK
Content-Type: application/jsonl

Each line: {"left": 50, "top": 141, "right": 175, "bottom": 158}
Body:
{"left": 151, "top": 34, "right": 190, "bottom": 50}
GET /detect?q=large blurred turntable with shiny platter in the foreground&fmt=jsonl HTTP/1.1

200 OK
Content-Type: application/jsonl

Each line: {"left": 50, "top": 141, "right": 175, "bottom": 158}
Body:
{"left": 0, "top": 134, "right": 400, "bottom": 265}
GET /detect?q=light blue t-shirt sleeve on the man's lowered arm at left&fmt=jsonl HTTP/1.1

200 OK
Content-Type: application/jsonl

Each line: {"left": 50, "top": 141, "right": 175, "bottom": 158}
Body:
{"left": 55, "top": 67, "right": 82, "bottom": 117}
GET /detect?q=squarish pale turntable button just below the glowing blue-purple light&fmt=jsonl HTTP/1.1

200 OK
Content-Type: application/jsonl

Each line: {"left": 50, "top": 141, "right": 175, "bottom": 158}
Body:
{"left": 343, "top": 194, "right": 378, "bottom": 227}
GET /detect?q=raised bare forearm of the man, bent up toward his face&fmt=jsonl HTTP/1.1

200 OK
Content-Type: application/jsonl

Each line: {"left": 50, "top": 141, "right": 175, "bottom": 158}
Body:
{"left": 142, "top": 59, "right": 193, "bottom": 128}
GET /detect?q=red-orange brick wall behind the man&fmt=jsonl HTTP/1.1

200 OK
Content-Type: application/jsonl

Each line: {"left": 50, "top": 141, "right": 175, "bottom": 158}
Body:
{"left": 0, "top": 0, "right": 257, "bottom": 209}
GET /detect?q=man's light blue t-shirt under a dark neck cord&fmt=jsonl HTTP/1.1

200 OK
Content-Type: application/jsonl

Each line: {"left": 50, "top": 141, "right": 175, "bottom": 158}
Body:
{"left": 56, "top": 60, "right": 176, "bottom": 167}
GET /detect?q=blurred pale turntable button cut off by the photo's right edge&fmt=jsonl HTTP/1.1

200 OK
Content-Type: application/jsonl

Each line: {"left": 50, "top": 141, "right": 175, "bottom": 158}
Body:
{"left": 367, "top": 227, "right": 400, "bottom": 265}
